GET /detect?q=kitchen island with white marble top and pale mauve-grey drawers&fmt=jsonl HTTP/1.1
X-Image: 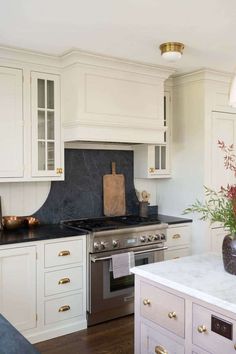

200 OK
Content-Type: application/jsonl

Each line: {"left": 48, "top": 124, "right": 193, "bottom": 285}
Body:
{"left": 132, "top": 253, "right": 236, "bottom": 354}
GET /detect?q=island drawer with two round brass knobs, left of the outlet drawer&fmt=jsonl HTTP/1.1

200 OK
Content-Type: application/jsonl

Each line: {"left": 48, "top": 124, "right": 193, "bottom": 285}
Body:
{"left": 140, "top": 282, "right": 185, "bottom": 338}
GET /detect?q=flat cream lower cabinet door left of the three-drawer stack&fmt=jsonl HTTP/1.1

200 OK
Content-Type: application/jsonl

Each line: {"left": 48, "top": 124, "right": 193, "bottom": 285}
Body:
{"left": 0, "top": 246, "right": 36, "bottom": 331}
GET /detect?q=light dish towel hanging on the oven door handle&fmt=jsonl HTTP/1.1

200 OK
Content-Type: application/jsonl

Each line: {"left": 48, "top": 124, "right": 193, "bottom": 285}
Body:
{"left": 112, "top": 252, "right": 135, "bottom": 279}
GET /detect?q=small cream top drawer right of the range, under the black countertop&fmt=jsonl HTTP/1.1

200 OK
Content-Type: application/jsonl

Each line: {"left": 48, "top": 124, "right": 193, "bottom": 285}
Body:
{"left": 167, "top": 226, "right": 191, "bottom": 247}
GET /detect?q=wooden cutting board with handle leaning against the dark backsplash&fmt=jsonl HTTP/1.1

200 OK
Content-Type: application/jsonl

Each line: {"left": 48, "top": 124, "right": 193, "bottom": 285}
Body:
{"left": 103, "top": 162, "right": 126, "bottom": 216}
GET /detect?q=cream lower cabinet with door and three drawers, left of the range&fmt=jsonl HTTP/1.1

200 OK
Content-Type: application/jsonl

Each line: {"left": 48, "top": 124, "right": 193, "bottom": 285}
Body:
{"left": 0, "top": 236, "right": 87, "bottom": 342}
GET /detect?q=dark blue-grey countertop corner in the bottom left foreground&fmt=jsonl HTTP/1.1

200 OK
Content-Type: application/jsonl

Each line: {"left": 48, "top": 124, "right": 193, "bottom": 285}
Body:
{"left": 0, "top": 314, "right": 39, "bottom": 354}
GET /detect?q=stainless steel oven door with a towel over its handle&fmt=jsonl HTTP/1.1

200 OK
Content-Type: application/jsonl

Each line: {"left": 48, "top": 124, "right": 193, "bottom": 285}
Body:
{"left": 88, "top": 247, "right": 167, "bottom": 319}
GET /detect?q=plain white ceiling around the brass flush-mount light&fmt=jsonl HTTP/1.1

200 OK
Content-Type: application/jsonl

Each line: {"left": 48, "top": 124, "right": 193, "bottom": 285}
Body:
{"left": 0, "top": 0, "right": 236, "bottom": 72}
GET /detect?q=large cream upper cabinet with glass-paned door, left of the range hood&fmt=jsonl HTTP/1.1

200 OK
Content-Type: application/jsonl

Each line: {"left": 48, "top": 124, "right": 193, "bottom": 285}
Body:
{"left": 0, "top": 48, "right": 64, "bottom": 182}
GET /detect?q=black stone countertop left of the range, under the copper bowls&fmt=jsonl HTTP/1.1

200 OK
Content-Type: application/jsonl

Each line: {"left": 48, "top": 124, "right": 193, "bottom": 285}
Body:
{"left": 0, "top": 224, "right": 86, "bottom": 245}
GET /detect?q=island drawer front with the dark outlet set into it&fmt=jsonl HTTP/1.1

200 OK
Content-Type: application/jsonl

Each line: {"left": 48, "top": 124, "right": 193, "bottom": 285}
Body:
{"left": 193, "top": 304, "right": 236, "bottom": 354}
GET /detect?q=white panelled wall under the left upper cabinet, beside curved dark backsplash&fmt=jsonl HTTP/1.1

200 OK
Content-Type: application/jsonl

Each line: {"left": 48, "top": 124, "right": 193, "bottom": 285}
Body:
{"left": 0, "top": 182, "right": 51, "bottom": 216}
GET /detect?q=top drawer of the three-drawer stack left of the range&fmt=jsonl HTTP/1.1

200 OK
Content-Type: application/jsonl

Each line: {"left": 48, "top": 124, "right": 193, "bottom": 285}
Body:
{"left": 44, "top": 240, "right": 83, "bottom": 268}
